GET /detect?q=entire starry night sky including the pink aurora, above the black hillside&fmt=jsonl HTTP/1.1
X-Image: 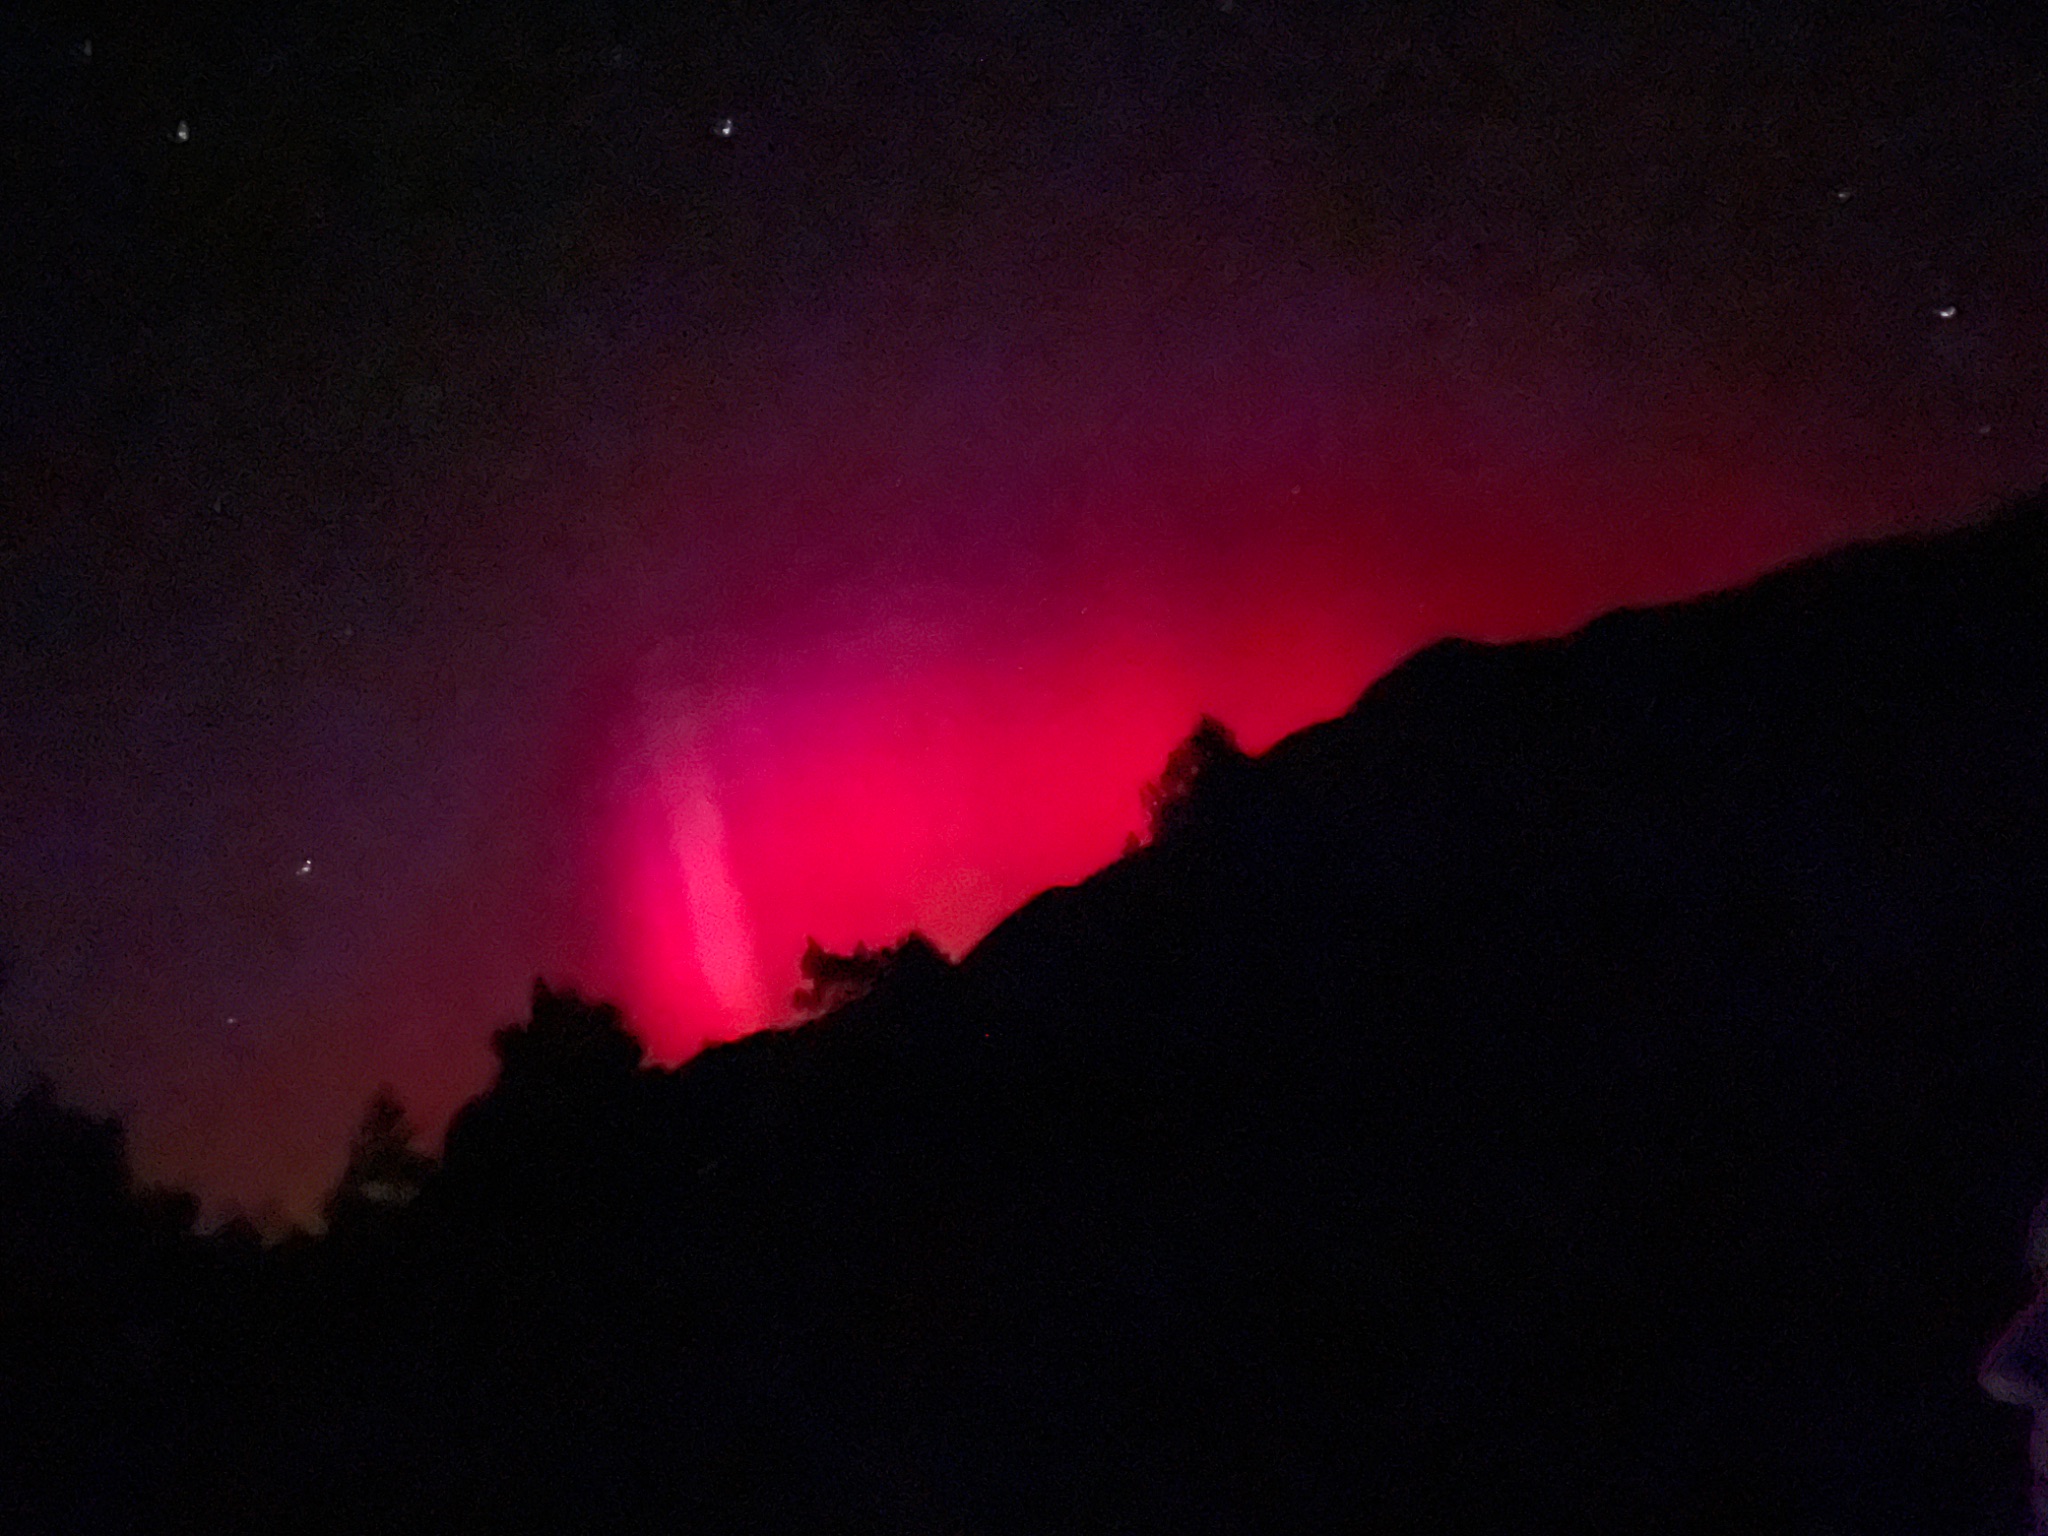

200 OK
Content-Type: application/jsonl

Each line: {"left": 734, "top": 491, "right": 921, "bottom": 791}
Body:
{"left": 0, "top": 0, "right": 2048, "bottom": 1212}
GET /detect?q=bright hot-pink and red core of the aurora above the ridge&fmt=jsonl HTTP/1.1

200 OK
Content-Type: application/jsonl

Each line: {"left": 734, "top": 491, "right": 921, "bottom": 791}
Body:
{"left": 596, "top": 479, "right": 1507, "bottom": 1059}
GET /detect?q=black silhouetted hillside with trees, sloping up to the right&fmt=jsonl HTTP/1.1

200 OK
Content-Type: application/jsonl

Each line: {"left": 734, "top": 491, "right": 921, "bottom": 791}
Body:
{"left": 8, "top": 506, "right": 2048, "bottom": 1534}
